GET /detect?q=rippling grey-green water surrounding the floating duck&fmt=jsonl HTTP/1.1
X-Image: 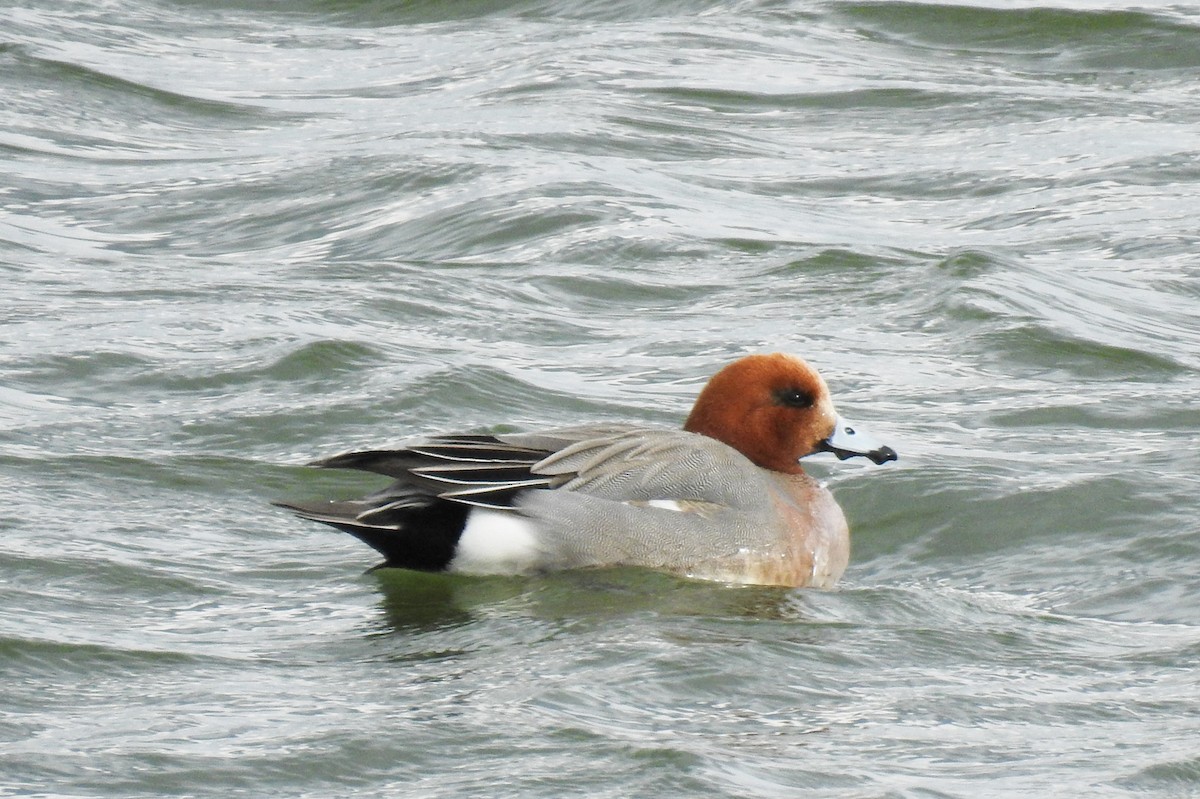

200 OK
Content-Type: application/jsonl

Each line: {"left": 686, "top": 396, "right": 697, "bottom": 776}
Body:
{"left": 0, "top": 0, "right": 1200, "bottom": 798}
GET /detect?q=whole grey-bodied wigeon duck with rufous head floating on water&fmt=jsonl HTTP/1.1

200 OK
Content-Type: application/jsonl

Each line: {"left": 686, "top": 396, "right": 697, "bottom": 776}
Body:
{"left": 277, "top": 353, "right": 896, "bottom": 588}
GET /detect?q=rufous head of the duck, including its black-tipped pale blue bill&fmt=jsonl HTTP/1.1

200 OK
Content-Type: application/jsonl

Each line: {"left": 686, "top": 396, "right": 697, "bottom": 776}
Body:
{"left": 684, "top": 353, "right": 896, "bottom": 474}
